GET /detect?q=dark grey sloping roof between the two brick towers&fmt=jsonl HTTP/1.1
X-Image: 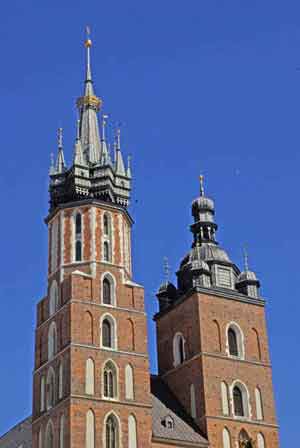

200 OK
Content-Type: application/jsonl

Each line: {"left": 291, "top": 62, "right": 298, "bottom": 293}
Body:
{"left": 151, "top": 375, "right": 208, "bottom": 447}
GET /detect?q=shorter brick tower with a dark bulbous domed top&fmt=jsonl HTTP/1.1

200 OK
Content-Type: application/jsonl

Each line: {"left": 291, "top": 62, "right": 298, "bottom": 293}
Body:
{"left": 155, "top": 178, "right": 279, "bottom": 448}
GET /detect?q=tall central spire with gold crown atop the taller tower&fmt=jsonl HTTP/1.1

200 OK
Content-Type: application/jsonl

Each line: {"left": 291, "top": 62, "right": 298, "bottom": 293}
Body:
{"left": 77, "top": 27, "right": 101, "bottom": 163}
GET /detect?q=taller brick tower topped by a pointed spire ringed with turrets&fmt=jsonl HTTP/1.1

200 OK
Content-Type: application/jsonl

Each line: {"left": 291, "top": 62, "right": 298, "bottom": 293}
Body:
{"left": 32, "top": 36, "right": 152, "bottom": 448}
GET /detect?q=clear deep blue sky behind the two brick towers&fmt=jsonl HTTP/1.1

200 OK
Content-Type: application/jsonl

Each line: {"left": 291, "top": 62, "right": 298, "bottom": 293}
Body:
{"left": 0, "top": 0, "right": 300, "bottom": 447}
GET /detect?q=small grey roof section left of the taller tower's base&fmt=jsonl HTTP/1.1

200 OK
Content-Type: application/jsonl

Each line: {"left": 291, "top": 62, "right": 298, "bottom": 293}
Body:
{"left": 0, "top": 417, "right": 32, "bottom": 448}
